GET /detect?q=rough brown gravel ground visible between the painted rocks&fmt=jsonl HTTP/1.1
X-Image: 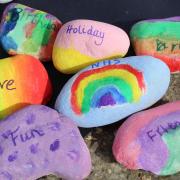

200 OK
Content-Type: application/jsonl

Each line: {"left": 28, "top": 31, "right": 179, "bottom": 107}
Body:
{"left": 39, "top": 74, "right": 180, "bottom": 180}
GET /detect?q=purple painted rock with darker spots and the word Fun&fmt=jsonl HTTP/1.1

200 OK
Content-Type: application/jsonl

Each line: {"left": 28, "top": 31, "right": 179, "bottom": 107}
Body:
{"left": 0, "top": 105, "right": 91, "bottom": 180}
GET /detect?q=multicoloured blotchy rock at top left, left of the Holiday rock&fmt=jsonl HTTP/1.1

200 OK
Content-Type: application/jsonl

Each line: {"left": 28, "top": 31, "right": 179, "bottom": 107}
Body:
{"left": 0, "top": 3, "right": 61, "bottom": 61}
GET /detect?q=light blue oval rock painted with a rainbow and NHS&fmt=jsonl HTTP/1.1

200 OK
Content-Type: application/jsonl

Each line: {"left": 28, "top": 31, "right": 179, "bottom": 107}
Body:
{"left": 55, "top": 56, "right": 170, "bottom": 127}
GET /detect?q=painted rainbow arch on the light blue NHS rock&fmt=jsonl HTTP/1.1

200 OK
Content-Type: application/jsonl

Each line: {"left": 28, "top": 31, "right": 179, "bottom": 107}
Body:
{"left": 71, "top": 64, "right": 145, "bottom": 115}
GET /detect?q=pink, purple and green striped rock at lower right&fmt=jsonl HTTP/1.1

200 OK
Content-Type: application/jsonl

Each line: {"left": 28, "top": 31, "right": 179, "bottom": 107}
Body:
{"left": 113, "top": 101, "right": 180, "bottom": 175}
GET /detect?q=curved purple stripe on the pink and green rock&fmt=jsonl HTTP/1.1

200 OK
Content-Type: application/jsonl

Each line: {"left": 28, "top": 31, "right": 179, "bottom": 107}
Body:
{"left": 138, "top": 111, "right": 180, "bottom": 173}
